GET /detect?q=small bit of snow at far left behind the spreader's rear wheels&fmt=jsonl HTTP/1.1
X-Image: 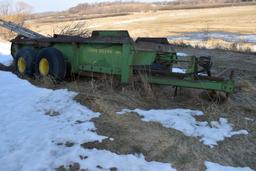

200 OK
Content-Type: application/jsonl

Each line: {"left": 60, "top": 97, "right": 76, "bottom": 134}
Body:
{"left": 0, "top": 42, "right": 13, "bottom": 66}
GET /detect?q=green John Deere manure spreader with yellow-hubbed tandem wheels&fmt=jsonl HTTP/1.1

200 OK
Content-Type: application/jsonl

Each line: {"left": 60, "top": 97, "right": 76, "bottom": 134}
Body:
{"left": 0, "top": 20, "right": 235, "bottom": 96}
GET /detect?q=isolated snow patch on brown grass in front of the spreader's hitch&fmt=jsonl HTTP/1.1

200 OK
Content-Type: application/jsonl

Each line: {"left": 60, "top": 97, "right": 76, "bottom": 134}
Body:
{"left": 117, "top": 109, "right": 248, "bottom": 148}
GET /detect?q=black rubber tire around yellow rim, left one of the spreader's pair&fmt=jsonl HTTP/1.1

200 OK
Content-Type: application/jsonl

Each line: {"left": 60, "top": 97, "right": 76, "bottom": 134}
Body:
{"left": 14, "top": 47, "right": 37, "bottom": 76}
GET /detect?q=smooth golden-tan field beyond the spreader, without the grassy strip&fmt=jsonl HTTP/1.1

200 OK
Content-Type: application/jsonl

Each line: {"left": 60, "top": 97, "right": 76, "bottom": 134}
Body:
{"left": 30, "top": 6, "right": 256, "bottom": 37}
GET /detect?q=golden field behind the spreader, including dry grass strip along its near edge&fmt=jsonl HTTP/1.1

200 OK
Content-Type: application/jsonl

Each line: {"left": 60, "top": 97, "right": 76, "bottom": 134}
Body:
{"left": 27, "top": 5, "right": 256, "bottom": 52}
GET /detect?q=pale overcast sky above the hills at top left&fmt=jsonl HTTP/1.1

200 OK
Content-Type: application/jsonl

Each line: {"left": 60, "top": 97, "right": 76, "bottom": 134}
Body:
{"left": 9, "top": 0, "right": 171, "bottom": 12}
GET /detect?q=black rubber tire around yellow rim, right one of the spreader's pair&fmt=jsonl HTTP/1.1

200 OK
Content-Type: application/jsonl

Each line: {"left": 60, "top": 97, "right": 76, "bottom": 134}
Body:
{"left": 35, "top": 47, "right": 67, "bottom": 81}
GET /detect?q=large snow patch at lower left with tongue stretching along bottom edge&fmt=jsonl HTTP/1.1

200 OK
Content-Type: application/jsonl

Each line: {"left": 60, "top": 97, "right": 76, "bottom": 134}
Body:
{"left": 0, "top": 71, "right": 175, "bottom": 171}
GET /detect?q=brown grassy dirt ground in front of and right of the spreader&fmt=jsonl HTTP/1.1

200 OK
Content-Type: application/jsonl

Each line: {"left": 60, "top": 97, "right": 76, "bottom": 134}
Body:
{"left": 2, "top": 47, "right": 256, "bottom": 171}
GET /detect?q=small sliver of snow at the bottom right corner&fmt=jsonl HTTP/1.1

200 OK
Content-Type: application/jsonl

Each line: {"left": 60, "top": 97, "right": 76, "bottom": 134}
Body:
{"left": 204, "top": 161, "right": 253, "bottom": 171}
